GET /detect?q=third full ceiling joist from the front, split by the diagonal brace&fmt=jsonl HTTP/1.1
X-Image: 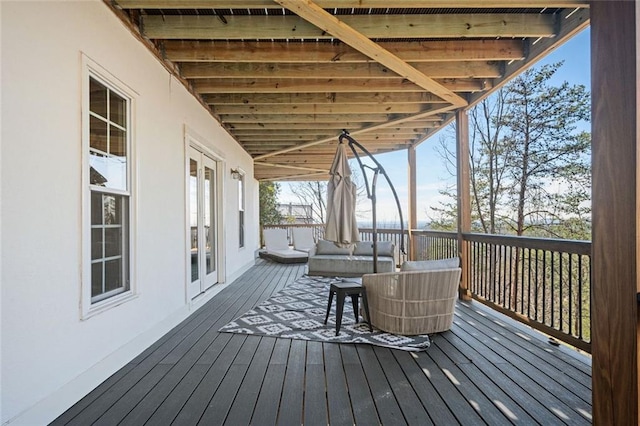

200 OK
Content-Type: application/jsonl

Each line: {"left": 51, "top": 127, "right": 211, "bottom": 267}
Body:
{"left": 180, "top": 61, "right": 502, "bottom": 79}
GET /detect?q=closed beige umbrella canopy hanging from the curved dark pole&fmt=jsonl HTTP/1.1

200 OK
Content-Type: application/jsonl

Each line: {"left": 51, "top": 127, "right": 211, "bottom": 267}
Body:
{"left": 325, "top": 143, "right": 360, "bottom": 246}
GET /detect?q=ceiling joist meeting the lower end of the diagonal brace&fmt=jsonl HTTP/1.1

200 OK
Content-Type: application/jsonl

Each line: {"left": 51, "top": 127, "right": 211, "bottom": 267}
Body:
{"left": 202, "top": 92, "right": 444, "bottom": 106}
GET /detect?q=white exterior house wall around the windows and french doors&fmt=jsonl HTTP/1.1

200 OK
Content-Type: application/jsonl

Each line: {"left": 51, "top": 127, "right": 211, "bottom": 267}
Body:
{"left": 0, "top": 0, "right": 259, "bottom": 424}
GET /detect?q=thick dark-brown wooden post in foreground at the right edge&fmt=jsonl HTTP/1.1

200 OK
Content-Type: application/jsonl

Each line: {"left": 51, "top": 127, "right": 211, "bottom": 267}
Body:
{"left": 590, "top": 1, "right": 640, "bottom": 425}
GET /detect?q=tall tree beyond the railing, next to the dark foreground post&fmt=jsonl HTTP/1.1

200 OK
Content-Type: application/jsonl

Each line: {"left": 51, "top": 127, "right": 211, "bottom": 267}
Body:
{"left": 502, "top": 62, "right": 591, "bottom": 236}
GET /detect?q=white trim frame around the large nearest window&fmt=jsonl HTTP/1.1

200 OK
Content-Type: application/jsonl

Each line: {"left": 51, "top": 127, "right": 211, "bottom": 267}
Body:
{"left": 80, "top": 54, "right": 139, "bottom": 320}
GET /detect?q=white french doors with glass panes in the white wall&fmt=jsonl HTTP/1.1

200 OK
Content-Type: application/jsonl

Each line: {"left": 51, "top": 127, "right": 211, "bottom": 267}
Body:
{"left": 188, "top": 147, "right": 219, "bottom": 299}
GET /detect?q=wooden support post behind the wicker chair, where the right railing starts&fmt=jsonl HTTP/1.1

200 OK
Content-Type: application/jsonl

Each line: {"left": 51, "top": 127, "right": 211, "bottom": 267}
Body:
{"left": 456, "top": 109, "right": 471, "bottom": 300}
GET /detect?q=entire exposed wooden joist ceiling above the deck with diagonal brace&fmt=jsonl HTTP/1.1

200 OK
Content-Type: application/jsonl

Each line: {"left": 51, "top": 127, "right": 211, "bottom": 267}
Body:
{"left": 103, "top": 0, "right": 590, "bottom": 180}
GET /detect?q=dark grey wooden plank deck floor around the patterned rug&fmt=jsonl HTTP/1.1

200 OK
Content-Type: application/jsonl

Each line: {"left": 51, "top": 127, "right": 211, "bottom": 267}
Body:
{"left": 53, "top": 260, "right": 591, "bottom": 426}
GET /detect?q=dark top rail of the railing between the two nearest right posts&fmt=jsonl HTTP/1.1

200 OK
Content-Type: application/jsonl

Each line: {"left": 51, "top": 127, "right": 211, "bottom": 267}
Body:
{"left": 462, "top": 233, "right": 591, "bottom": 256}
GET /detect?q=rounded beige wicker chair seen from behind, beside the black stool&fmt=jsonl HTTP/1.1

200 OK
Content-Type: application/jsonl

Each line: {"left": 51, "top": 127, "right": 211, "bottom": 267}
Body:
{"left": 362, "top": 268, "right": 462, "bottom": 336}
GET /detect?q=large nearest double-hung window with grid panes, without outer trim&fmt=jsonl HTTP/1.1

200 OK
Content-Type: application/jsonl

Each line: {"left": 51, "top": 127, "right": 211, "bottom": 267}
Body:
{"left": 84, "top": 70, "right": 132, "bottom": 306}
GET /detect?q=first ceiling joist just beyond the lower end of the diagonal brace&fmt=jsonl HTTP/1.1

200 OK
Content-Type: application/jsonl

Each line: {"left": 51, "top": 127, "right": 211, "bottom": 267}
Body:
{"left": 212, "top": 104, "right": 430, "bottom": 115}
